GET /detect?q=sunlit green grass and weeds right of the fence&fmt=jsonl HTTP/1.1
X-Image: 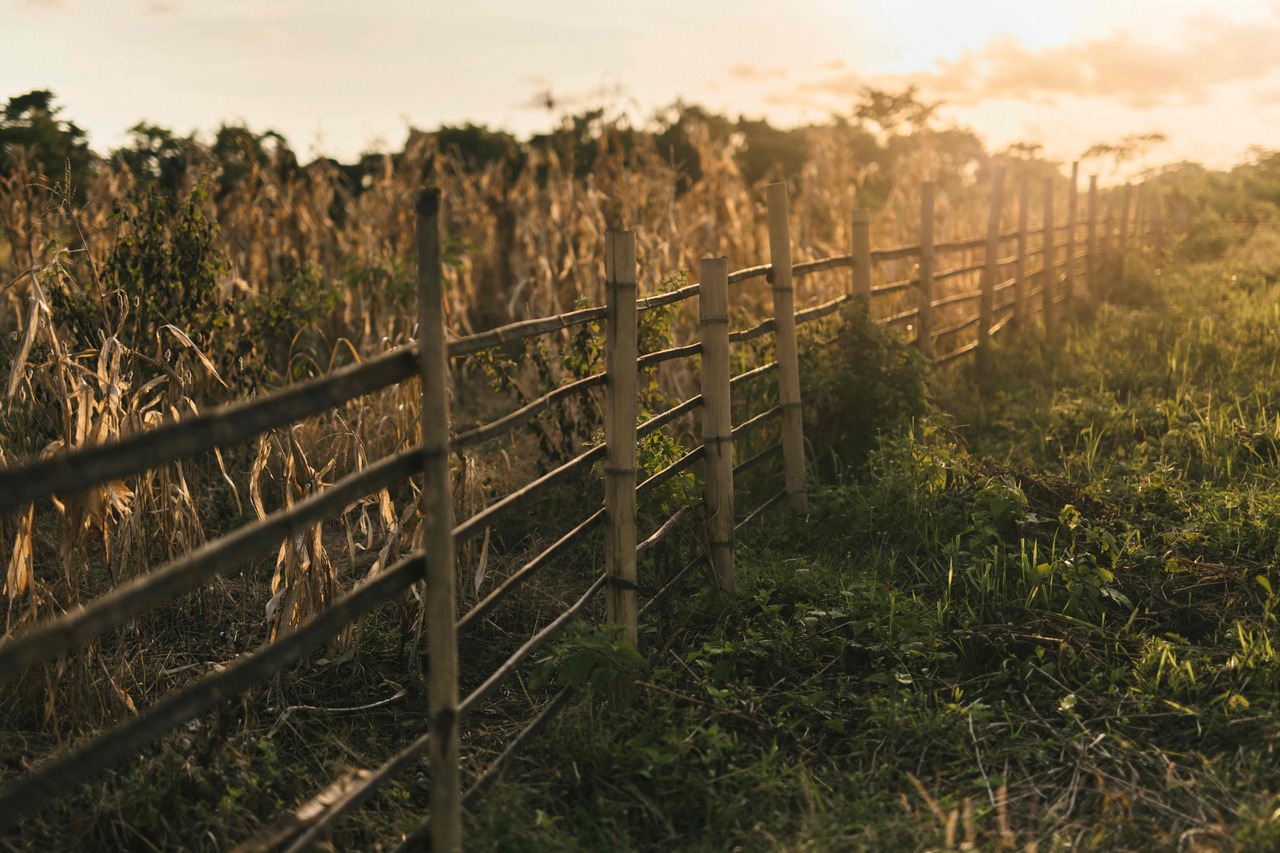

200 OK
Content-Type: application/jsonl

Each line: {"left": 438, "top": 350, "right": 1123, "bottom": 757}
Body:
{"left": 467, "top": 234, "right": 1280, "bottom": 850}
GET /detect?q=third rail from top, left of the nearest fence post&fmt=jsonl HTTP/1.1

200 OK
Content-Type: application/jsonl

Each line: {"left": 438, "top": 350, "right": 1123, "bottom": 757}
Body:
{"left": 0, "top": 555, "right": 424, "bottom": 829}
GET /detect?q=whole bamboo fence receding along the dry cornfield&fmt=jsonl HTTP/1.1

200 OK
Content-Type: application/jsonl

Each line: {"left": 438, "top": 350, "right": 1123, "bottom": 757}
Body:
{"left": 0, "top": 170, "right": 1162, "bottom": 850}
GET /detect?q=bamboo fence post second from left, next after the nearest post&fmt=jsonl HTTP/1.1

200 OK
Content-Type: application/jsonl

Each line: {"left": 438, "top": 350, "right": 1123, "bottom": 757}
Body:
{"left": 604, "top": 231, "right": 640, "bottom": 648}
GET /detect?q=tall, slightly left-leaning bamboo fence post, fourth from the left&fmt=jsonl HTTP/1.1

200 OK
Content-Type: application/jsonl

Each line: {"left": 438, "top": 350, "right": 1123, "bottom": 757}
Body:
{"left": 764, "top": 182, "right": 809, "bottom": 515}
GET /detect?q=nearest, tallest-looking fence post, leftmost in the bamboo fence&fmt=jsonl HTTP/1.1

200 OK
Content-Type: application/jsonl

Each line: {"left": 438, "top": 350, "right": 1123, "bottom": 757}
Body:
{"left": 413, "top": 187, "right": 462, "bottom": 852}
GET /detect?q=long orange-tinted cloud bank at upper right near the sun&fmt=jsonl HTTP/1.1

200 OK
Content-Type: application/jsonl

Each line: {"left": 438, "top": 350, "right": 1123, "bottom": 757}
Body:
{"left": 771, "top": 17, "right": 1280, "bottom": 109}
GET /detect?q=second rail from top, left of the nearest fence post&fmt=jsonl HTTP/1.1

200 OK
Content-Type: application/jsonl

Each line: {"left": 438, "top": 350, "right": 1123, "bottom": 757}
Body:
{"left": 0, "top": 448, "right": 422, "bottom": 683}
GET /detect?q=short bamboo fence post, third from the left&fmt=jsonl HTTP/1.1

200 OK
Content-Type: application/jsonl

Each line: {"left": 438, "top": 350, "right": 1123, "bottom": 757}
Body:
{"left": 698, "top": 257, "right": 733, "bottom": 599}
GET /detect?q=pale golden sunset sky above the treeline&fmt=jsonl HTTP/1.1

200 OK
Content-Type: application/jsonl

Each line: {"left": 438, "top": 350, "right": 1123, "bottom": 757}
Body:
{"left": 0, "top": 0, "right": 1280, "bottom": 167}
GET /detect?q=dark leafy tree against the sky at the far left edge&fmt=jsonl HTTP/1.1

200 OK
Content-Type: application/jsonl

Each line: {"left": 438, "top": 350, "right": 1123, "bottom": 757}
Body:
{"left": 0, "top": 88, "right": 93, "bottom": 201}
